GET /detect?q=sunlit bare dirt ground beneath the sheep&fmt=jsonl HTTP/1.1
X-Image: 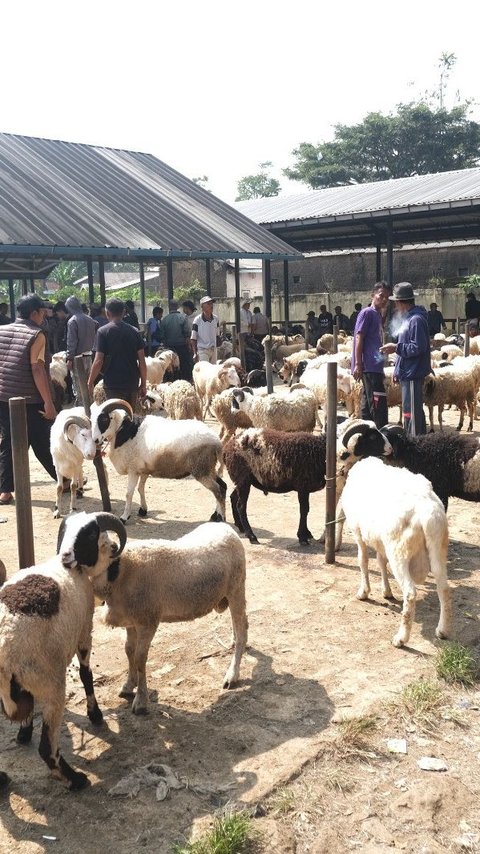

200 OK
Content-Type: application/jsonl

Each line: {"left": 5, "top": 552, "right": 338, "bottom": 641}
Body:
{"left": 0, "top": 413, "right": 480, "bottom": 854}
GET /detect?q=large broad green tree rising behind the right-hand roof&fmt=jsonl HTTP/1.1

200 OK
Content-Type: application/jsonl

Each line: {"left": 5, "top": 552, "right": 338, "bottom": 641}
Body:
{"left": 283, "top": 53, "right": 480, "bottom": 188}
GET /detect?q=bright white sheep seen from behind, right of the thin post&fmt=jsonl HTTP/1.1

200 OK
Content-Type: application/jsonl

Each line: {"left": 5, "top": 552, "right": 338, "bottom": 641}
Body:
{"left": 341, "top": 457, "right": 452, "bottom": 647}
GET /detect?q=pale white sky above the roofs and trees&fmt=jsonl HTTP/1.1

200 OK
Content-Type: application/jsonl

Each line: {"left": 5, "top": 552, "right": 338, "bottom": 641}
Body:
{"left": 0, "top": 0, "right": 480, "bottom": 203}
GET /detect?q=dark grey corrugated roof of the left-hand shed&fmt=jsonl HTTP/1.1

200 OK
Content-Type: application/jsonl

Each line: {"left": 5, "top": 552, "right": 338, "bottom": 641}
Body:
{"left": 0, "top": 134, "right": 298, "bottom": 270}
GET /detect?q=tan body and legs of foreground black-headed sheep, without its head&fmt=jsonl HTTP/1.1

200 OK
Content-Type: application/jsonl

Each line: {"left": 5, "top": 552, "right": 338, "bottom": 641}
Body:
{"left": 94, "top": 522, "right": 248, "bottom": 715}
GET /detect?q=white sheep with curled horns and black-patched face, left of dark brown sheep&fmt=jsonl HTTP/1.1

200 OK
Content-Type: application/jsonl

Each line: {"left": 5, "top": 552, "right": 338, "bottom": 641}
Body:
{"left": 91, "top": 400, "right": 227, "bottom": 522}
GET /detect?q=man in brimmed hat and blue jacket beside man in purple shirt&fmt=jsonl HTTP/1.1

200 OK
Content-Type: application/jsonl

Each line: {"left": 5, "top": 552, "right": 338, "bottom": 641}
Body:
{"left": 380, "top": 282, "right": 432, "bottom": 436}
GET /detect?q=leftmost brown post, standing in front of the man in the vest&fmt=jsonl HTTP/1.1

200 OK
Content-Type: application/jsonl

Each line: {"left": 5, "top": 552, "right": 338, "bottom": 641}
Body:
{"left": 9, "top": 397, "right": 35, "bottom": 569}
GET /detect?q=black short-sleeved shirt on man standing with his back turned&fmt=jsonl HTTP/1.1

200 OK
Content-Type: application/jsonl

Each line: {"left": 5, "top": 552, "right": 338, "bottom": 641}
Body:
{"left": 95, "top": 320, "right": 144, "bottom": 391}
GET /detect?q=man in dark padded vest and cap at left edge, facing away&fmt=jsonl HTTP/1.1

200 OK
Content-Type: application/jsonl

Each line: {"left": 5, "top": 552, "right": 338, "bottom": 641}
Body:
{"left": 0, "top": 294, "right": 57, "bottom": 504}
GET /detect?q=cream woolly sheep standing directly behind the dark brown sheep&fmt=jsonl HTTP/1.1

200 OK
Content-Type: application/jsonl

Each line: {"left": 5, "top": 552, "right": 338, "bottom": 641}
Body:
{"left": 232, "top": 387, "right": 318, "bottom": 433}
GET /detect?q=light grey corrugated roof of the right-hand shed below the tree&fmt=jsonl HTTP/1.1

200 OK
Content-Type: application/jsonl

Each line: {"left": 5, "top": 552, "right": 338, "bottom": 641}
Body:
{"left": 236, "top": 167, "right": 480, "bottom": 223}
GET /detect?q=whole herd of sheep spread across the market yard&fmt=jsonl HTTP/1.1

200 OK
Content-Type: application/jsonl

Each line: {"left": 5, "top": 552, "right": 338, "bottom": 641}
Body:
{"left": 0, "top": 336, "right": 480, "bottom": 789}
